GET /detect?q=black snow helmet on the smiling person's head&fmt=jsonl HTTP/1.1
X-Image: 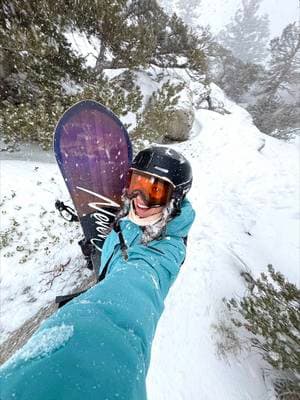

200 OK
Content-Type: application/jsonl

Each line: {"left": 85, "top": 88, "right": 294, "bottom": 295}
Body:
{"left": 131, "top": 146, "right": 193, "bottom": 201}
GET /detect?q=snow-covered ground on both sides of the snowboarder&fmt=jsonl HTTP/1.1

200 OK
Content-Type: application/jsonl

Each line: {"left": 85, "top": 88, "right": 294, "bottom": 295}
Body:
{"left": 0, "top": 79, "right": 300, "bottom": 400}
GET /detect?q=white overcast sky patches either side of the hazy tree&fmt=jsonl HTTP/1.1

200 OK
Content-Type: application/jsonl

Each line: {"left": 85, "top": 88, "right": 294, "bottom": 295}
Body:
{"left": 199, "top": 0, "right": 299, "bottom": 37}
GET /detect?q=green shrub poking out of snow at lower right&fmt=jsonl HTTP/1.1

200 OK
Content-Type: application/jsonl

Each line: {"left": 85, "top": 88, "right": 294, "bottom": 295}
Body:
{"left": 224, "top": 265, "right": 300, "bottom": 400}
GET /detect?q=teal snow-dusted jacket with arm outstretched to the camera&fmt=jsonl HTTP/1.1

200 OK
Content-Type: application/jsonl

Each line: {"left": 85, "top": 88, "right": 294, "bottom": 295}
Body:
{"left": 0, "top": 200, "right": 195, "bottom": 400}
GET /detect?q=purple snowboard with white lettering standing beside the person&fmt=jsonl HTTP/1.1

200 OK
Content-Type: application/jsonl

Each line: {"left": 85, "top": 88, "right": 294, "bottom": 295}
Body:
{"left": 54, "top": 100, "right": 132, "bottom": 270}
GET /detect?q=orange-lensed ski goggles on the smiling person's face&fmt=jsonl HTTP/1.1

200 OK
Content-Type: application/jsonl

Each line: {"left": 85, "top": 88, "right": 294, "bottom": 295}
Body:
{"left": 127, "top": 169, "right": 174, "bottom": 207}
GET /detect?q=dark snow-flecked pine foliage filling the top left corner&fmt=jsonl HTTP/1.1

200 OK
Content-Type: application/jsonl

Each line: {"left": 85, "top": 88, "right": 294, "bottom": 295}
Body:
{"left": 0, "top": 0, "right": 84, "bottom": 104}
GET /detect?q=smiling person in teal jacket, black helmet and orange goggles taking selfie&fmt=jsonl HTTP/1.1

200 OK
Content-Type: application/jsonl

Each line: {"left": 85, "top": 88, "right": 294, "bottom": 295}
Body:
{"left": 0, "top": 146, "right": 195, "bottom": 400}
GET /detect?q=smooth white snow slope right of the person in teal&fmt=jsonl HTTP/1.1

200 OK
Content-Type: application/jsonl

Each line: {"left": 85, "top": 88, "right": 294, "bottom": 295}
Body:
{"left": 148, "top": 86, "right": 300, "bottom": 400}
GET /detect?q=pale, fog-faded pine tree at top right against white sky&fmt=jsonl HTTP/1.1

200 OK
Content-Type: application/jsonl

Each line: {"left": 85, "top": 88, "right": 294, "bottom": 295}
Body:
{"left": 218, "top": 0, "right": 269, "bottom": 63}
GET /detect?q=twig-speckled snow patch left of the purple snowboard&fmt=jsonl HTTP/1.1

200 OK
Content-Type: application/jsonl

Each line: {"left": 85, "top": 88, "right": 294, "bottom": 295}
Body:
{"left": 0, "top": 160, "right": 90, "bottom": 343}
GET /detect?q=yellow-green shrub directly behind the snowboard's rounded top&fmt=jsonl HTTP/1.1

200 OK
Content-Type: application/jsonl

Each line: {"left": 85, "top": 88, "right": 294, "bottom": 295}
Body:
{"left": 0, "top": 79, "right": 142, "bottom": 149}
